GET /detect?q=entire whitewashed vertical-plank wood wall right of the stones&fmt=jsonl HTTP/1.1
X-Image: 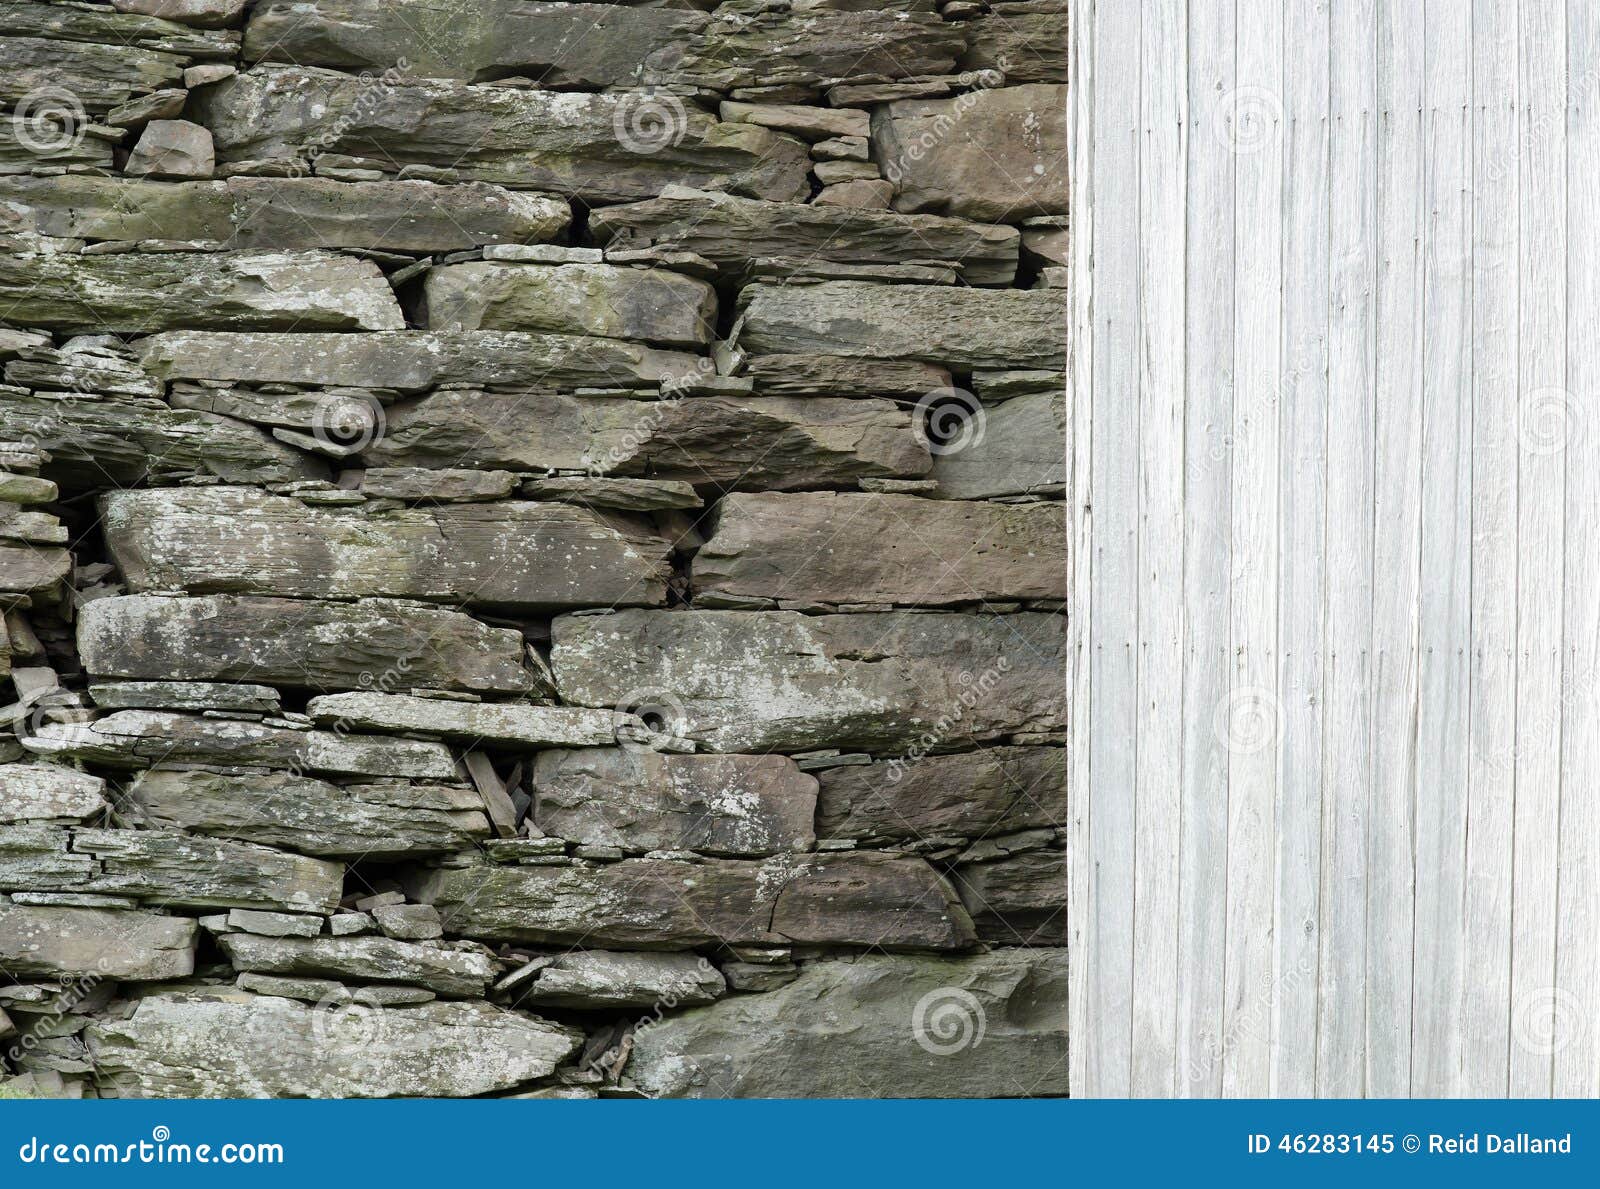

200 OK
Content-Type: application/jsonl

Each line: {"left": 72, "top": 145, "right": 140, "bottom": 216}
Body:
{"left": 1067, "top": 0, "right": 1600, "bottom": 1096}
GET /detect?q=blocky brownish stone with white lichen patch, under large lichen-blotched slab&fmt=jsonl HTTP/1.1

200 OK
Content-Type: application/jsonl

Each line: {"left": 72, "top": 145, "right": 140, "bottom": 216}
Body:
{"left": 533, "top": 747, "right": 816, "bottom": 856}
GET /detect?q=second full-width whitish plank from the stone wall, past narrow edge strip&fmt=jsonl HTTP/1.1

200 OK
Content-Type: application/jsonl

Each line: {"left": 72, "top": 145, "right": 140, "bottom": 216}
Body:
{"left": 1133, "top": 0, "right": 1187, "bottom": 1098}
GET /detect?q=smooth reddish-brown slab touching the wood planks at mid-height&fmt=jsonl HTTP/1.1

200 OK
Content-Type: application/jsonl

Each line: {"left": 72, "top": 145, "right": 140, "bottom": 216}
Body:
{"left": 691, "top": 491, "right": 1067, "bottom": 607}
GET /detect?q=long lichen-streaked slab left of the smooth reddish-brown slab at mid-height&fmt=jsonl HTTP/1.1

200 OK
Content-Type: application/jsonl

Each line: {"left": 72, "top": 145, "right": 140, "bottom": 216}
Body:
{"left": 101, "top": 486, "right": 669, "bottom": 611}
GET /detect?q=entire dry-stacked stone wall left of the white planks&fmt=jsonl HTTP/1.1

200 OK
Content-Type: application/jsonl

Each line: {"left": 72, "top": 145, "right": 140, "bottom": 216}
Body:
{"left": 9, "top": 0, "right": 1069, "bottom": 1098}
